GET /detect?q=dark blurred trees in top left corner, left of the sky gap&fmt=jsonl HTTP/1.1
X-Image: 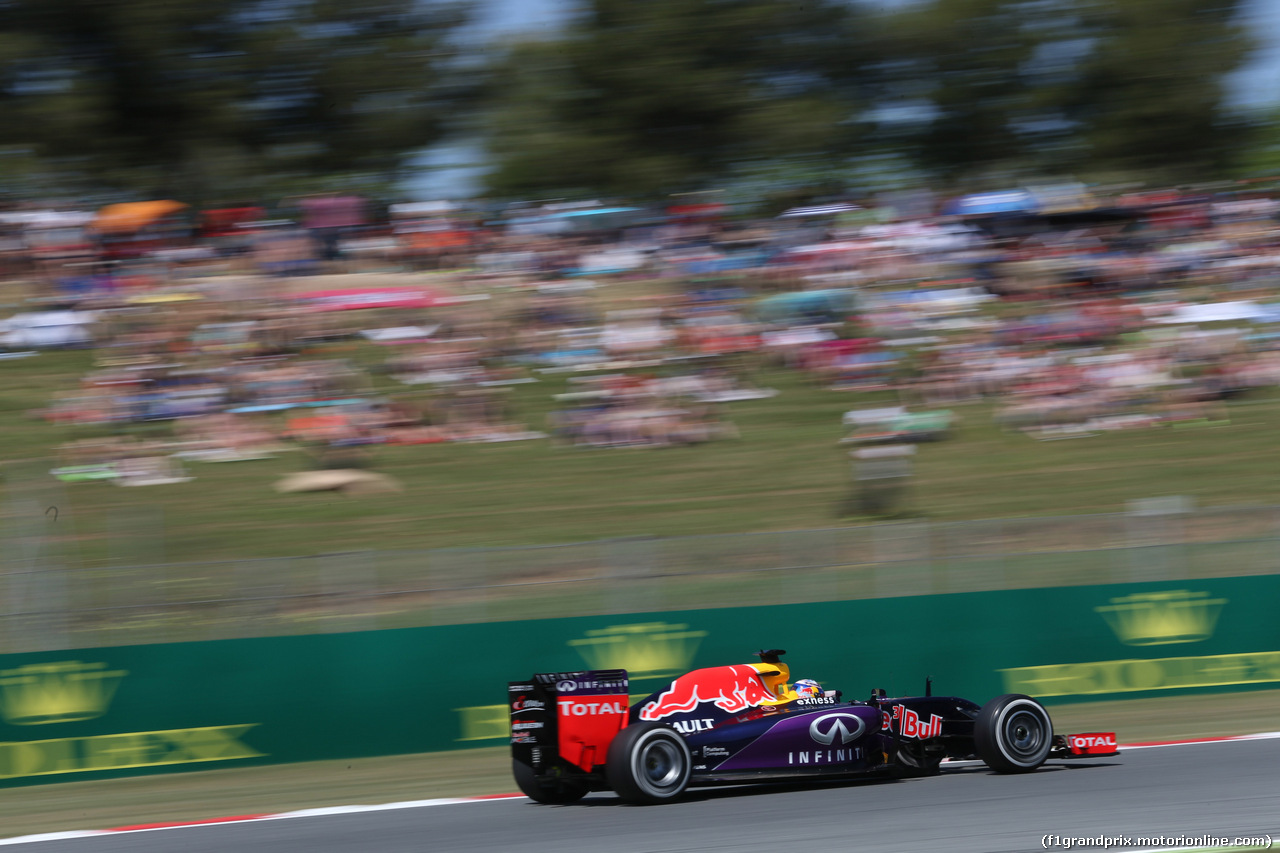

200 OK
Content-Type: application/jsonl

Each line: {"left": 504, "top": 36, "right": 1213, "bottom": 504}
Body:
{"left": 0, "top": 0, "right": 467, "bottom": 200}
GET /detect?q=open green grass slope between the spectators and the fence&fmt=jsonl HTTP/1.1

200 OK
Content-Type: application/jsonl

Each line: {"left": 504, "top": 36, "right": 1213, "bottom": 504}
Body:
{"left": 0, "top": 343, "right": 1280, "bottom": 566}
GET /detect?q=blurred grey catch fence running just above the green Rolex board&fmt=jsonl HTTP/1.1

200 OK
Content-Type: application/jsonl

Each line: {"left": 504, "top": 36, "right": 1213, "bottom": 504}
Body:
{"left": 0, "top": 503, "right": 1280, "bottom": 653}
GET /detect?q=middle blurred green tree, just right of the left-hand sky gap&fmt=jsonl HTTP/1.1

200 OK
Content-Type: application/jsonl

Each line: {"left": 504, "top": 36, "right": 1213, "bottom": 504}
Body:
{"left": 488, "top": 0, "right": 859, "bottom": 197}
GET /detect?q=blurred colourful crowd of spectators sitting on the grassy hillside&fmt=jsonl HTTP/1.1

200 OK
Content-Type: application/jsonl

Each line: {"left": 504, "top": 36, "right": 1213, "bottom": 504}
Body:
{"left": 4, "top": 180, "right": 1280, "bottom": 482}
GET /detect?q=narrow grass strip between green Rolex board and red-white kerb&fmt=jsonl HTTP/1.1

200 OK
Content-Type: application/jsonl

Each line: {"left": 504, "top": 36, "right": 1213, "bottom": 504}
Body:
{"left": 0, "top": 690, "right": 1280, "bottom": 838}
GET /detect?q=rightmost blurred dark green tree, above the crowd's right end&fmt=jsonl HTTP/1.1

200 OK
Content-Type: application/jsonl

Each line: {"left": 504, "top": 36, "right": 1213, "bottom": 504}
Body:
{"left": 882, "top": 0, "right": 1251, "bottom": 182}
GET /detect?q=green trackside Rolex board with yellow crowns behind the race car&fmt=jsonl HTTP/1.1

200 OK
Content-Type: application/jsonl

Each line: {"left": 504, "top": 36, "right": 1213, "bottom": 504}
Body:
{"left": 0, "top": 576, "right": 1280, "bottom": 786}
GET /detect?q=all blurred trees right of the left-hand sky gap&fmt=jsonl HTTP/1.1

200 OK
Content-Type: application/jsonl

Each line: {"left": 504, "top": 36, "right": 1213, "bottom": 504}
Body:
{"left": 478, "top": 0, "right": 1251, "bottom": 195}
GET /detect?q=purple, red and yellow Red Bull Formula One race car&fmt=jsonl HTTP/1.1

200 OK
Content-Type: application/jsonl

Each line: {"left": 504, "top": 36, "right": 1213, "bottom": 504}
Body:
{"left": 507, "top": 649, "right": 1119, "bottom": 804}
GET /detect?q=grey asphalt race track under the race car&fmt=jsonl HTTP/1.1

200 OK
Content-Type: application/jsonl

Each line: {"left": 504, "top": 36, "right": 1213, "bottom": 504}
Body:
{"left": 9, "top": 739, "right": 1280, "bottom": 853}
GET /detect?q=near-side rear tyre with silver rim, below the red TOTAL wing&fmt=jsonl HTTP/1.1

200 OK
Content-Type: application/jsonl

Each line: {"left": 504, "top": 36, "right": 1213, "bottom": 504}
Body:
{"left": 605, "top": 722, "right": 694, "bottom": 804}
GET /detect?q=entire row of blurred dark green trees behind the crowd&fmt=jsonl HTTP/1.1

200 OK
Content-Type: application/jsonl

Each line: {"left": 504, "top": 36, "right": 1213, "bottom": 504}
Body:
{"left": 0, "top": 0, "right": 1258, "bottom": 201}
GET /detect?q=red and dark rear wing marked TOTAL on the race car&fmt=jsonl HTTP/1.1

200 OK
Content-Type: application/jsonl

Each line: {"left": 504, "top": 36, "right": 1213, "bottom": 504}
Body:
{"left": 507, "top": 670, "right": 630, "bottom": 774}
